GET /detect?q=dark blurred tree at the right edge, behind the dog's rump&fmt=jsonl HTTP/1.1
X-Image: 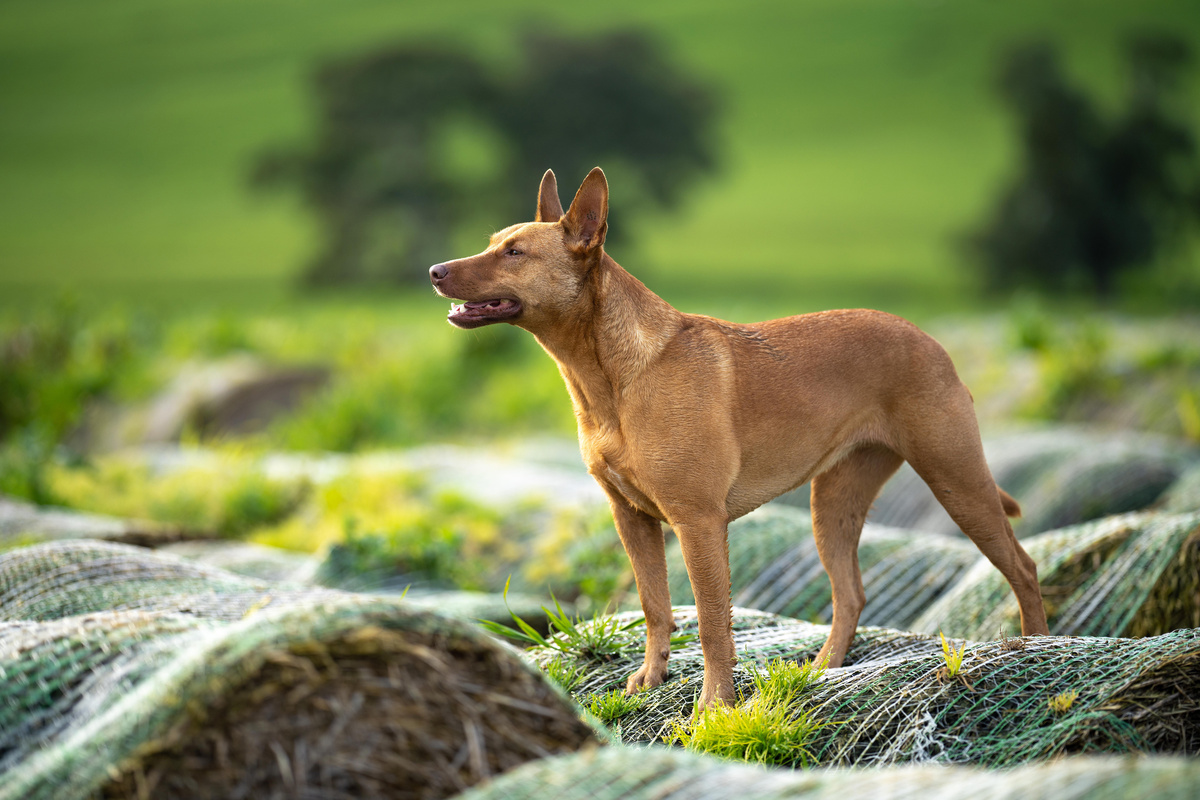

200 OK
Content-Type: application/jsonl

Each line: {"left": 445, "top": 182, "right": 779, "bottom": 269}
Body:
{"left": 968, "top": 35, "right": 1200, "bottom": 296}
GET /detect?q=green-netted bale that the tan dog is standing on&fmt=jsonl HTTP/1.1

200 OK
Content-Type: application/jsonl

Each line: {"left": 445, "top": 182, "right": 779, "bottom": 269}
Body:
{"left": 534, "top": 609, "right": 1200, "bottom": 766}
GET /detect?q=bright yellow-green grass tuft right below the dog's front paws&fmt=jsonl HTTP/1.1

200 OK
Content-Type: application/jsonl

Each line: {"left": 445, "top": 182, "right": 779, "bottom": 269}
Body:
{"left": 672, "top": 660, "right": 829, "bottom": 766}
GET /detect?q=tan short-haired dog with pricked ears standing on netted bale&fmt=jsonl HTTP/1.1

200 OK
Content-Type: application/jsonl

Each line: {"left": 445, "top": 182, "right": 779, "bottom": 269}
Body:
{"left": 430, "top": 168, "right": 1049, "bottom": 706}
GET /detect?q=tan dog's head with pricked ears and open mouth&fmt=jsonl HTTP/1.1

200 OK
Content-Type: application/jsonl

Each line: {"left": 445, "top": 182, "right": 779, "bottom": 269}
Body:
{"left": 430, "top": 167, "right": 608, "bottom": 330}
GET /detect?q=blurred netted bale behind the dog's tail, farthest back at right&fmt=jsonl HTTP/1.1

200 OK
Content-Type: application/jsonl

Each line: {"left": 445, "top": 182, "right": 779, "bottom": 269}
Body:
{"left": 785, "top": 428, "right": 1198, "bottom": 537}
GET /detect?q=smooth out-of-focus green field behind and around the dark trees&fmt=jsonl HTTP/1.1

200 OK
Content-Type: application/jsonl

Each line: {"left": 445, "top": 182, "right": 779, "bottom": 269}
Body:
{"left": 0, "top": 0, "right": 1200, "bottom": 318}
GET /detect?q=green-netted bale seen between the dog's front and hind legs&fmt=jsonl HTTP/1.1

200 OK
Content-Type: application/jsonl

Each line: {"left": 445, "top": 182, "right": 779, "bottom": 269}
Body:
{"left": 667, "top": 505, "right": 980, "bottom": 628}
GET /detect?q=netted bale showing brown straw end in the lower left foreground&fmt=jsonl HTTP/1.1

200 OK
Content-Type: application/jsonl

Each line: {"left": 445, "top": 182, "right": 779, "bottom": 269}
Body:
{"left": 0, "top": 595, "right": 596, "bottom": 800}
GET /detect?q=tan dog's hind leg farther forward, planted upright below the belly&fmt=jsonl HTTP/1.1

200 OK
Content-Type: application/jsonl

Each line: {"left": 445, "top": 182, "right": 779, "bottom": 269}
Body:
{"left": 812, "top": 445, "right": 904, "bottom": 667}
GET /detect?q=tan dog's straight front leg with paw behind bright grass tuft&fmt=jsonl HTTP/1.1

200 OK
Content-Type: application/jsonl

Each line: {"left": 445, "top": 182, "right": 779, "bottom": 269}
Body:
{"left": 672, "top": 513, "right": 738, "bottom": 709}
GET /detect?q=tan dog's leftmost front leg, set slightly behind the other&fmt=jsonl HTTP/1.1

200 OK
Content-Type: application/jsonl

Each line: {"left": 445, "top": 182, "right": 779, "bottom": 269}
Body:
{"left": 608, "top": 493, "right": 676, "bottom": 694}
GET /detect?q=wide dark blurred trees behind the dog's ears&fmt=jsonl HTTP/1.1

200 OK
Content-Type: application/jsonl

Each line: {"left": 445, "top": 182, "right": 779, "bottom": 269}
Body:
{"left": 252, "top": 32, "right": 715, "bottom": 284}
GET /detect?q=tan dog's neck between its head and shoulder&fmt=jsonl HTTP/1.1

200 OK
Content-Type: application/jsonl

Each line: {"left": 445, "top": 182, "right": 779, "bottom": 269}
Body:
{"left": 534, "top": 251, "right": 683, "bottom": 425}
